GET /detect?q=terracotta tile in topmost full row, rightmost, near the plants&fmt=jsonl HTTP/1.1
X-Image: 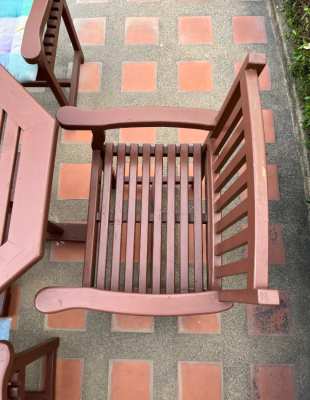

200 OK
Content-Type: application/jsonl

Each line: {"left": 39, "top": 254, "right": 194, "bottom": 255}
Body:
{"left": 232, "top": 16, "right": 267, "bottom": 44}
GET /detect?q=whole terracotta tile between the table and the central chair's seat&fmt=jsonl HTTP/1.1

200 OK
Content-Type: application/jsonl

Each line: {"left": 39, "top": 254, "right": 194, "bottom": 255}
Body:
{"left": 58, "top": 164, "right": 91, "bottom": 200}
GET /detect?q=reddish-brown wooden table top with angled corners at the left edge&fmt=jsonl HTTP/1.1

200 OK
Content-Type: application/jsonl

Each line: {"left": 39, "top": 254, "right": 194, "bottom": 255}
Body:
{"left": 0, "top": 67, "right": 57, "bottom": 290}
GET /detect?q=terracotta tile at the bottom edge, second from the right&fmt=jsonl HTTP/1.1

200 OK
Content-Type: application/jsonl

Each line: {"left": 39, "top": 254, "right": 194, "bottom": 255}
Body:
{"left": 178, "top": 361, "right": 222, "bottom": 400}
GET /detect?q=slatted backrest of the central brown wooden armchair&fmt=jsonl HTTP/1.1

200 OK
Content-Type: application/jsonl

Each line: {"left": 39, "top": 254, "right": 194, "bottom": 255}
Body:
{"left": 206, "top": 54, "right": 276, "bottom": 303}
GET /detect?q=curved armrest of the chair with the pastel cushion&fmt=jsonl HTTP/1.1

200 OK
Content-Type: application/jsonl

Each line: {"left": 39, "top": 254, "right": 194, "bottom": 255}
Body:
{"left": 21, "top": 0, "right": 52, "bottom": 64}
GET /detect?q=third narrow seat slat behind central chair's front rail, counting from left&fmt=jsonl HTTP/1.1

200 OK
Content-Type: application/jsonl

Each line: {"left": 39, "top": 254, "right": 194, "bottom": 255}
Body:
{"left": 125, "top": 144, "right": 138, "bottom": 292}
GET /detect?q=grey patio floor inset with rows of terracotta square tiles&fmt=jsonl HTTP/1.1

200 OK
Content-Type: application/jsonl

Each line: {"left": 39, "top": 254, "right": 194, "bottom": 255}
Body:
{"left": 11, "top": 0, "right": 310, "bottom": 400}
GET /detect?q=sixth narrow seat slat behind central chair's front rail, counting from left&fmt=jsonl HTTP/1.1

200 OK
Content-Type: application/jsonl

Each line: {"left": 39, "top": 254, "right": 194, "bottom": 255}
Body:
{"left": 166, "top": 144, "right": 176, "bottom": 293}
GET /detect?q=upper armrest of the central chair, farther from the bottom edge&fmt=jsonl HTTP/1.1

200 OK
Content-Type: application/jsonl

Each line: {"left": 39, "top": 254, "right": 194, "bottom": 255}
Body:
{"left": 56, "top": 106, "right": 217, "bottom": 131}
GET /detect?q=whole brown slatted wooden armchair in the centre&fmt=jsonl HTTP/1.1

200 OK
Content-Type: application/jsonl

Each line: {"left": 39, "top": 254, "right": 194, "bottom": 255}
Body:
{"left": 36, "top": 54, "right": 279, "bottom": 315}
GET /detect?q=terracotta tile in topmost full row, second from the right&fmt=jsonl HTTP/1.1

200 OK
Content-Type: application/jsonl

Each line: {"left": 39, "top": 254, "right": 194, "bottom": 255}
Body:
{"left": 178, "top": 16, "right": 213, "bottom": 44}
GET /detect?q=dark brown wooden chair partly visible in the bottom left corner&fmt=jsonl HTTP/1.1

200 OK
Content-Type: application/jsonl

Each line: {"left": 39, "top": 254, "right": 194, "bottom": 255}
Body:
{"left": 0, "top": 338, "right": 59, "bottom": 400}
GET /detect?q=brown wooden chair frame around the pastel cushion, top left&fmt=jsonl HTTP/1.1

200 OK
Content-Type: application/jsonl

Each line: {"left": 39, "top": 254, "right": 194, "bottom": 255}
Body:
{"left": 22, "top": 0, "right": 84, "bottom": 106}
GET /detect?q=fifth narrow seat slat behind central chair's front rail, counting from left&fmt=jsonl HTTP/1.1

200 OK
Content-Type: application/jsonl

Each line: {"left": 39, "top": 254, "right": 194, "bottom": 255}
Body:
{"left": 152, "top": 144, "right": 163, "bottom": 293}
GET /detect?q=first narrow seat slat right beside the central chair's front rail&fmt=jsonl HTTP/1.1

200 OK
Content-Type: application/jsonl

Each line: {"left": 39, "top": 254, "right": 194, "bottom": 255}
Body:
{"left": 97, "top": 143, "right": 113, "bottom": 289}
